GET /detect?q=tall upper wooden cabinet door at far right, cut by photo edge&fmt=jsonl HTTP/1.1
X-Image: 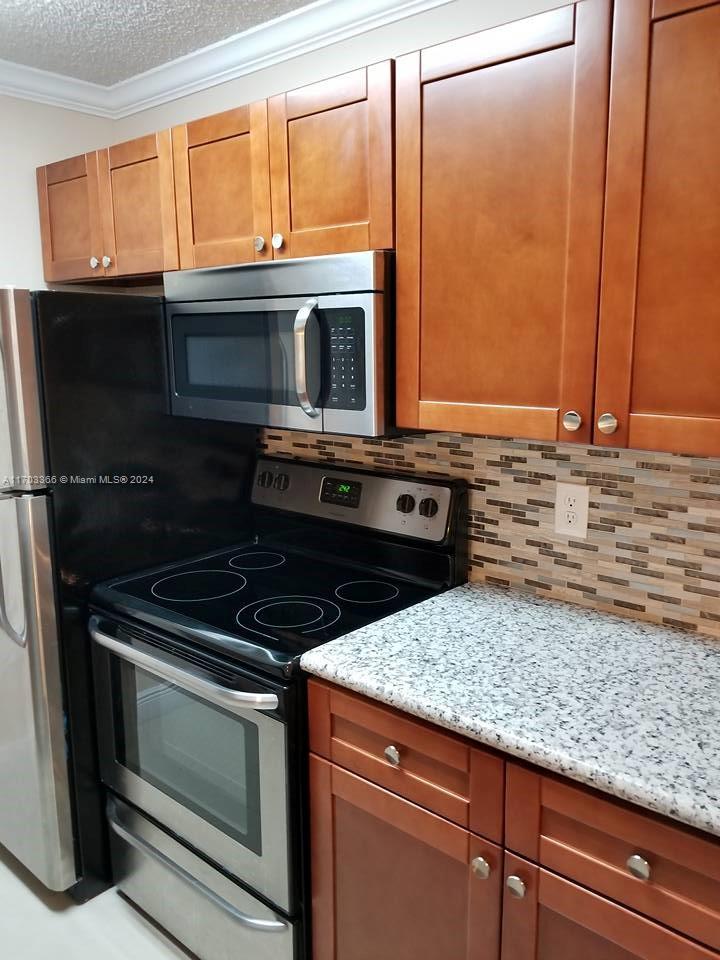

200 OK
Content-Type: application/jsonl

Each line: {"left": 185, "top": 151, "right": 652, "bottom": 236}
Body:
{"left": 595, "top": 0, "right": 720, "bottom": 456}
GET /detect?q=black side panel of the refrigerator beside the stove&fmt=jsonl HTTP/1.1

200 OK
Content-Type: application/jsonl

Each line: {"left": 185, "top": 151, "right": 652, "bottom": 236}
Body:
{"left": 34, "top": 292, "right": 256, "bottom": 899}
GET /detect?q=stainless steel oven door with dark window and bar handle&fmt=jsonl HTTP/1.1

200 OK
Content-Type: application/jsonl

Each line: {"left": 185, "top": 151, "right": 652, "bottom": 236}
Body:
{"left": 90, "top": 616, "right": 295, "bottom": 912}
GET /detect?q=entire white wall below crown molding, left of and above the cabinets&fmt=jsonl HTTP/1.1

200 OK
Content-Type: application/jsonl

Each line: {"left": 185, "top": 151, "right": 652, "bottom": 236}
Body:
{"left": 0, "top": 0, "right": 572, "bottom": 288}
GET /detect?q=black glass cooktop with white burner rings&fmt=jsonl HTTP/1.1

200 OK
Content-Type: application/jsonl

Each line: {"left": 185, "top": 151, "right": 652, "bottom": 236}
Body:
{"left": 93, "top": 543, "right": 437, "bottom": 673}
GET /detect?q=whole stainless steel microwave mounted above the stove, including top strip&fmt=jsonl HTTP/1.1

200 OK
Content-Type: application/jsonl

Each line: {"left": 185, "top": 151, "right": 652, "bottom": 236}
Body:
{"left": 164, "top": 251, "right": 392, "bottom": 437}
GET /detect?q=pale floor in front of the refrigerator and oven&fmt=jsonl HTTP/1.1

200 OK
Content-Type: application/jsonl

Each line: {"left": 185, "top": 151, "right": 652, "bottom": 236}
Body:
{"left": 0, "top": 847, "right": 191, "bottom": 960}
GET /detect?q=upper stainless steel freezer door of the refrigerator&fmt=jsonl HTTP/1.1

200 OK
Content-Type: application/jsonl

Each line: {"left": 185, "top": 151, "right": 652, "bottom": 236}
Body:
{"left": 0, "top": 287, "right": 47, "bottom": 491}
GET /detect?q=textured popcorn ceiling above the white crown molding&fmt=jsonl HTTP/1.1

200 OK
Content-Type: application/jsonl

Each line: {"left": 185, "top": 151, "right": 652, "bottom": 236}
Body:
{"left": 0, "top": 0, "right": 308, "bottom": 86}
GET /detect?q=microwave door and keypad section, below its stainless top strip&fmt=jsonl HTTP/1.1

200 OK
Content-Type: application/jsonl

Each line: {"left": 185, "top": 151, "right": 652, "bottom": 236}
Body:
{"left": 166, "top": 293, "right": 386, "bottom": 436}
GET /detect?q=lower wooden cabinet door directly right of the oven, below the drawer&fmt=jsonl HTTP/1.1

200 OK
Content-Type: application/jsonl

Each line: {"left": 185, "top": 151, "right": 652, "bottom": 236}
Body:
{"left": 310, "top": 756, "right": 502, "bottom": 960}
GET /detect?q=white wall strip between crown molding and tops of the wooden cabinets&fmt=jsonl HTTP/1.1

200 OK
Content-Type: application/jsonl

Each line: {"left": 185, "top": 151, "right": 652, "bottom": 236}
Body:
{"left": 115, "top": 0, "right": 573, "bottom": 142}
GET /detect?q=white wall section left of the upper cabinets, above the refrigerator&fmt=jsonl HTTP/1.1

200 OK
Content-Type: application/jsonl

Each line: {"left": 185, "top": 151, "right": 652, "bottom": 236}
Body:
{"left": 0, "top": 96, "right": 116, "bottom": 289}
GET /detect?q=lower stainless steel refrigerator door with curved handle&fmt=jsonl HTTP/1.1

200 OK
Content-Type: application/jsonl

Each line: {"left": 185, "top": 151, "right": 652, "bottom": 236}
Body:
{"left": 0, "top": 494, "right": 77, "bottom": 890}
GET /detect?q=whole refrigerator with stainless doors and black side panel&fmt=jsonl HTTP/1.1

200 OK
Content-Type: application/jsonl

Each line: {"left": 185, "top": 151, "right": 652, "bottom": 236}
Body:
{"left": 0, "top": 289, "right": 256, "bottom": 900}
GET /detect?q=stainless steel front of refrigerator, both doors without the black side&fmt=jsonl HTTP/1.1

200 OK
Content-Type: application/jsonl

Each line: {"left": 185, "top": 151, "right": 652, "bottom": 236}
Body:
{"left": 0, "top": 289, "right": 77, "bottom": 890}
